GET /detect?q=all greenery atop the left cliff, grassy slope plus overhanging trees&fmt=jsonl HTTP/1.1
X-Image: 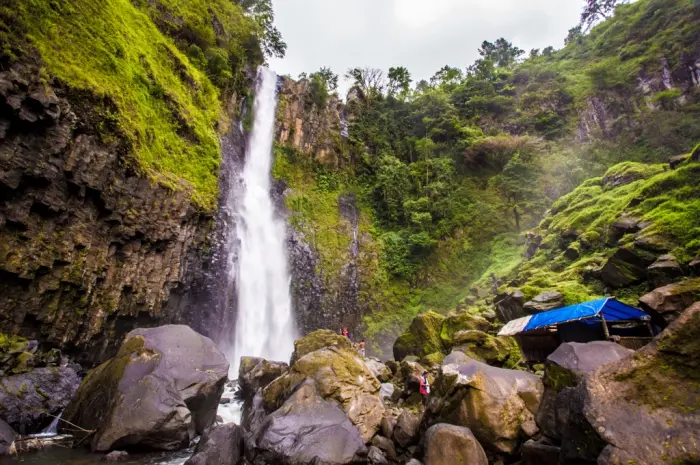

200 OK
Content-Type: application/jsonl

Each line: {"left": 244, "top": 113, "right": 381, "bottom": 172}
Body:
{"left": 0, "top": 0, "right": 284, "bottom": 209}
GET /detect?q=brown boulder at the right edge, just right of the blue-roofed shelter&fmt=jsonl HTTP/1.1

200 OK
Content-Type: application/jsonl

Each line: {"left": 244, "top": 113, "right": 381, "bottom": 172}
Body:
{"left": 639, "top": 278, "right": 700, "bottom": 327}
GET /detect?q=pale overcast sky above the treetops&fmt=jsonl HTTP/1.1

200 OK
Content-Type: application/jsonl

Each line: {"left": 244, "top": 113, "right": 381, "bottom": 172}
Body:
{"left": 270, "top": 0, "right": 584, "bottom": 96}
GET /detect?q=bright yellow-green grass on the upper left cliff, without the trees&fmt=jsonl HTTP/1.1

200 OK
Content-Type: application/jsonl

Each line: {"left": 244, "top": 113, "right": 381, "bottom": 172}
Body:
{"left": 2, "top": 0, "right": 260, "bottom": 210}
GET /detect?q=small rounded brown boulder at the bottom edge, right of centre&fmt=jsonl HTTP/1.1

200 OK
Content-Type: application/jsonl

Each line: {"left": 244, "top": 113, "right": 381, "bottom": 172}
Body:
{"left": 423, "top": 423, "right": 489, "bottom": 465}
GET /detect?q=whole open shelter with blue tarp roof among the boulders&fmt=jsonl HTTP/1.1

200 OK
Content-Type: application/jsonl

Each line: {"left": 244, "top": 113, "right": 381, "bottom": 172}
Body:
{"left": 498, "top": 297, "right": 654, "bottom": 363}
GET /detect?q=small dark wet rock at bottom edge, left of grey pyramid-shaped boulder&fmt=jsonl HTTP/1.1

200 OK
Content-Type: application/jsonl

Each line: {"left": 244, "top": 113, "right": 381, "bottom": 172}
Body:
{"left": 185, "top": 423, "right": 244, "bottom": 465}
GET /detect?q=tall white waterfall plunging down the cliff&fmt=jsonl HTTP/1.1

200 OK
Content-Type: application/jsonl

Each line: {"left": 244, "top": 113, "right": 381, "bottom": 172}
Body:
{"left": 229, "top": 68, "right": 296, "bottom": 378}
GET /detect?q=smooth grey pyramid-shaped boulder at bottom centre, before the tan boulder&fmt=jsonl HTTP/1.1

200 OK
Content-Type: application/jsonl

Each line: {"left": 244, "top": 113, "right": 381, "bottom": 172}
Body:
{"left": 246, "top": 379, "right": 367, "bottom": 465}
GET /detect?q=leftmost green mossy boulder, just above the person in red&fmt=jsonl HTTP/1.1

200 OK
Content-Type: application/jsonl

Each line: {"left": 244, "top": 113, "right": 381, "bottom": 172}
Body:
{"left": 394, "top": 311, "right": 445, "bottom": 360}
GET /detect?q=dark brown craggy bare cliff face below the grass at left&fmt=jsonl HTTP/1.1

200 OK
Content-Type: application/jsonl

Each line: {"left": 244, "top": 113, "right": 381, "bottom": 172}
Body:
{"left": 0, "top": 64, "right": 211, "bottom": 361}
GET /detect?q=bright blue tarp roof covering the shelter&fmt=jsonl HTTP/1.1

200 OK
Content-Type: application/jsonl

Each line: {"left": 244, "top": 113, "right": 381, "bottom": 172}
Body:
{"left": 522, "top": 297, "right": 649, "bottom": 332}
